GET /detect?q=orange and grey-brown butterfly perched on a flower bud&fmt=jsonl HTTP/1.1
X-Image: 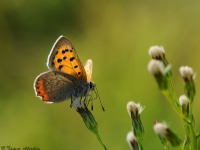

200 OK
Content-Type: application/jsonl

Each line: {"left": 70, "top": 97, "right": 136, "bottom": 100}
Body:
{"left": 34, "top": 36, "right": 95, "bottom": 103}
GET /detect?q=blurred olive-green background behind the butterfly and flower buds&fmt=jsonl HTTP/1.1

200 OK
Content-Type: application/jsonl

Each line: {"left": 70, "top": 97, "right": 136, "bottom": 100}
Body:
{"left": 0, "top": 0, "right": 200, "bottom": 150}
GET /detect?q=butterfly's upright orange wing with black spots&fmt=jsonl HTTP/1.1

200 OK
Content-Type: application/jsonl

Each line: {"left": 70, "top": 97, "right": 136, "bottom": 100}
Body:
{"left": 47, "top": 36, "right": 87, "bottom": 82}
